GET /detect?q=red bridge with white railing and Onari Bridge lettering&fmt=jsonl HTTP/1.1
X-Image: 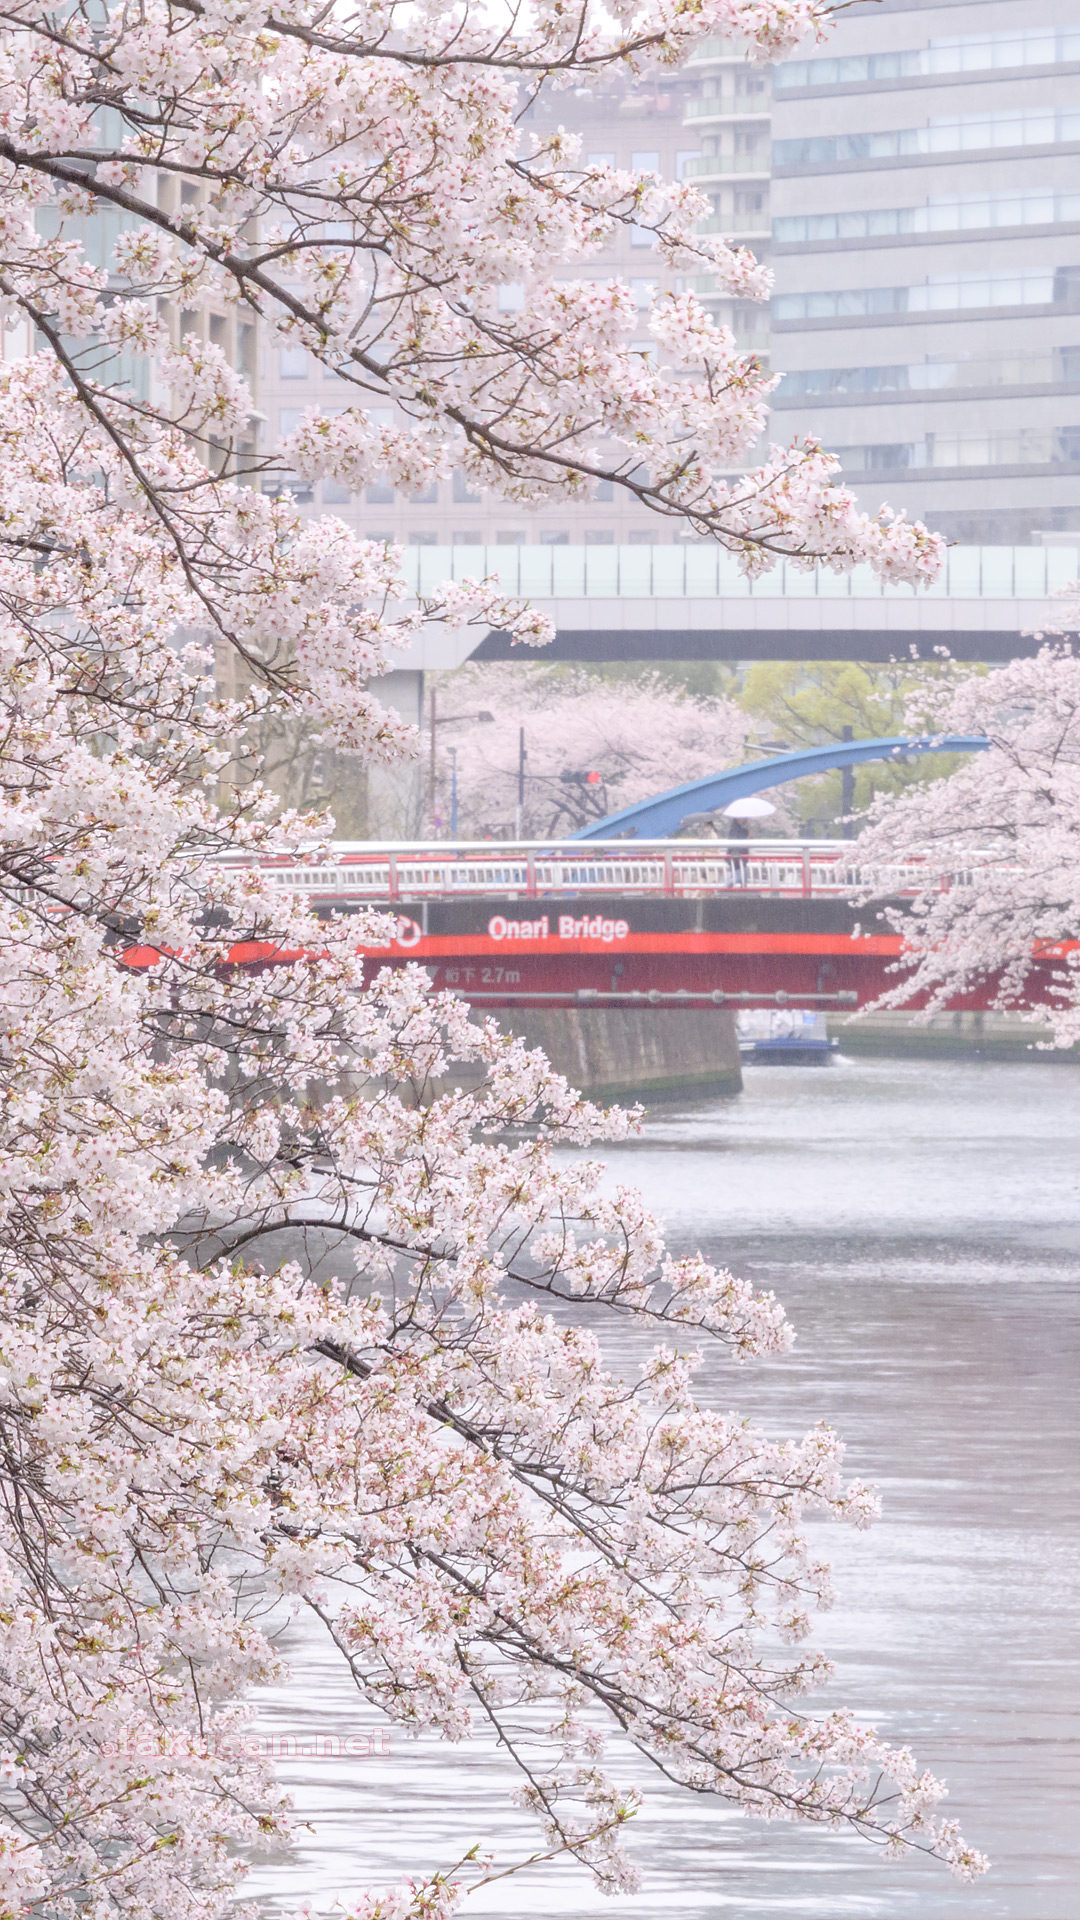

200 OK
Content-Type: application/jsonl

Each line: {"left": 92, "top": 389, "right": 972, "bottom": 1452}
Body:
{"left": 220, "top": 841, "right": 1063, "bottom": 1010}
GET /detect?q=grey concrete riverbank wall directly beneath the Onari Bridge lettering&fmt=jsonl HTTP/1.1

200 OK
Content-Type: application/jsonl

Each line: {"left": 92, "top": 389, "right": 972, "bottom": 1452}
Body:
{"left": 498, "top": 1006, "right": 742, "bottom": 1102}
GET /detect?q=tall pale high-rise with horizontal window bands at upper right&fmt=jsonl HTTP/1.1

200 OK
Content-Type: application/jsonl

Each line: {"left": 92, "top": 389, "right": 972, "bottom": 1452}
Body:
{"left": 771, "top": 0, "right": 1080, "bottom": 543}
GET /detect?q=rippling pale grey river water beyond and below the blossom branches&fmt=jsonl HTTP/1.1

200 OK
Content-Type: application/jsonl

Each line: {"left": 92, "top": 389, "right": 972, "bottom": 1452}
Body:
{"left": 252, "top": 1056, "right": 1080, "bottom": 1920}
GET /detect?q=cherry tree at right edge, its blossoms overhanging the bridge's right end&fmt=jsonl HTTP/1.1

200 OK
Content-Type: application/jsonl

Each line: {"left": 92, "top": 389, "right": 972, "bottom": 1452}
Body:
{"left": 845, "top": 645, "right": 1080, "bottom": 1046}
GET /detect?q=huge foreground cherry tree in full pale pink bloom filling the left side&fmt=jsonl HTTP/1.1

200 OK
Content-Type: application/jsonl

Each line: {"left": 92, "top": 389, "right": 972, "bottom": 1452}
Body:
{"left": 0, "top": 0, "right": 982, "bottom": 1920}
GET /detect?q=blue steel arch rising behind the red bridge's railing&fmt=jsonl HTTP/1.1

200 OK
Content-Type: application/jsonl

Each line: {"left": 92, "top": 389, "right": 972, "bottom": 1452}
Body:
{"left": 569, "top": 733, "right": 990, "bottom": 839}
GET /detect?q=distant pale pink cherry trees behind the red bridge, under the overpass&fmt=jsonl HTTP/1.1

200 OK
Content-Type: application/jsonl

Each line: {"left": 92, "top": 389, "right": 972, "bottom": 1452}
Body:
{"left": 426, "top": 662, "right": 749, "bottom": 839}
